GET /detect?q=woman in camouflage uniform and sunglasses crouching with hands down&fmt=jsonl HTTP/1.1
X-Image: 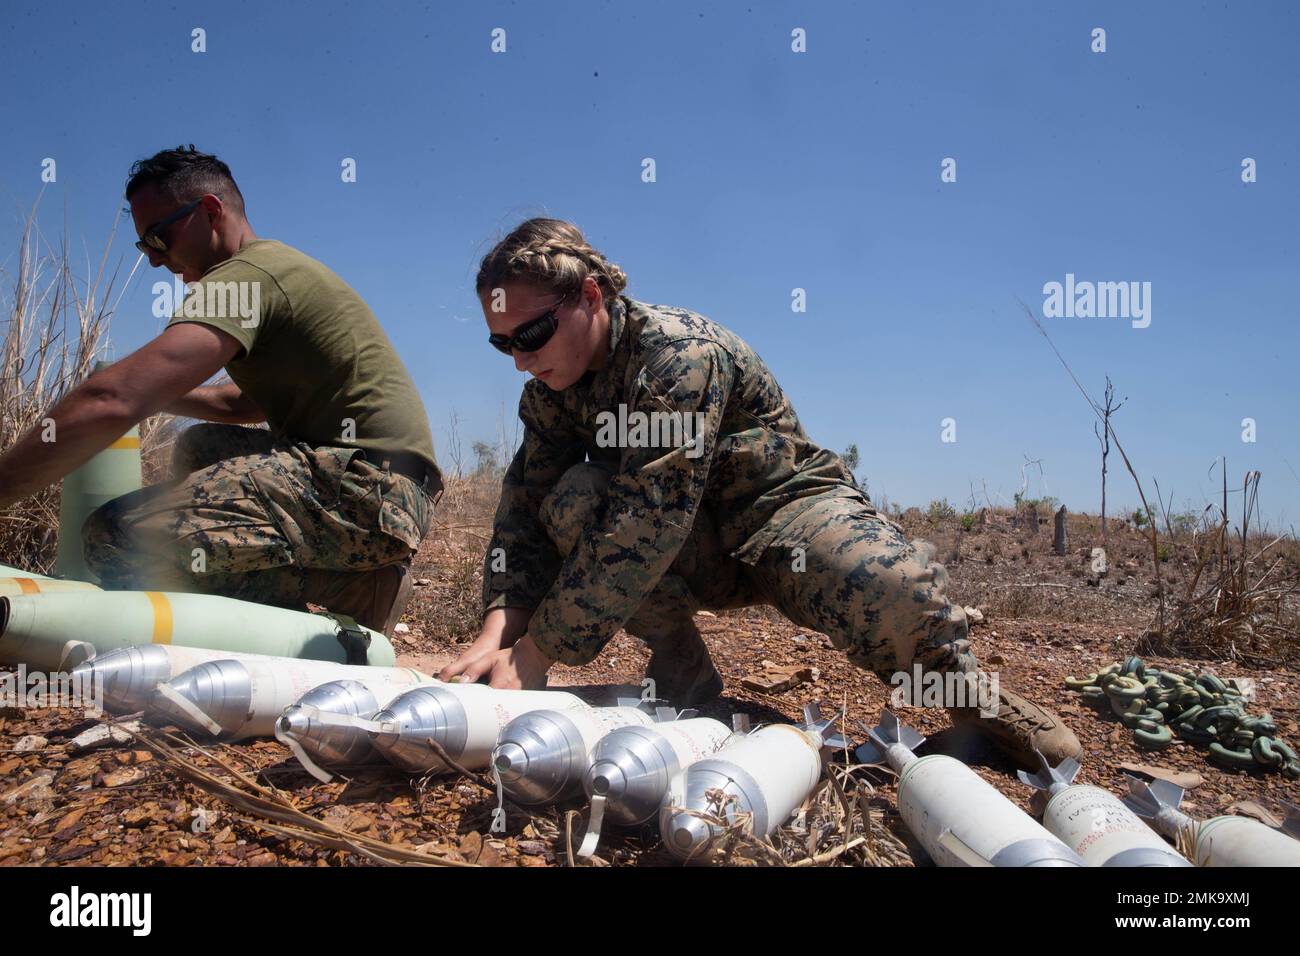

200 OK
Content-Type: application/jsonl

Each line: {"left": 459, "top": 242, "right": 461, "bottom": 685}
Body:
{"left": 441, "top": 219, "right": 1080, "bottom": 766}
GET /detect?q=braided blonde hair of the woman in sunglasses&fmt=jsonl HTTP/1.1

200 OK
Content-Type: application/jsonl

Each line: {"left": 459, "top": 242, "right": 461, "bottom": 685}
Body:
{"left": 475, "top": 219, "right": 628, "bottom": 304}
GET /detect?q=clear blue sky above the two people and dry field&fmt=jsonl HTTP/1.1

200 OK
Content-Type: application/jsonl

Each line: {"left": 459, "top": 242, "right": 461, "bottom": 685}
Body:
{"left": 0, "top": 0, "right": 1300, "bottom": 529}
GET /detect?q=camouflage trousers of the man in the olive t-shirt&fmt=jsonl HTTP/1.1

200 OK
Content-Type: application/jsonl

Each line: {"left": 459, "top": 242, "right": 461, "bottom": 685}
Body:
{"left": 82, "top": 423, "right": 433, "bottom": 607}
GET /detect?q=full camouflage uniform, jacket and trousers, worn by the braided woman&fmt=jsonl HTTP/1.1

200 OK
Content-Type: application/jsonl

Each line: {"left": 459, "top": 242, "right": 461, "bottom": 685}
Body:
{"left": 484, "top": 297, "right": 975, "bottom": 680}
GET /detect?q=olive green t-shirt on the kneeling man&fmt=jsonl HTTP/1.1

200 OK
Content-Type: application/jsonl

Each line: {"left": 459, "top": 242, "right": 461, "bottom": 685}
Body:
{"left": 172, "top": 239, "right": 437, "bottom": 468}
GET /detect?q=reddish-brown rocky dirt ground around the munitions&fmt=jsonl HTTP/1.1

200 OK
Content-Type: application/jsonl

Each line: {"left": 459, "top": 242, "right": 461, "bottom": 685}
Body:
{"left": 0, "top": 489, "right": 1300, "bottom": 866}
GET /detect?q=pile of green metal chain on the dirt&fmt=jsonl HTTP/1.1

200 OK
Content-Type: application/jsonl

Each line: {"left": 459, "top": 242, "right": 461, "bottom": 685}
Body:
{"left": 1065, "top": 657, "right": 1300, "bottom": 779}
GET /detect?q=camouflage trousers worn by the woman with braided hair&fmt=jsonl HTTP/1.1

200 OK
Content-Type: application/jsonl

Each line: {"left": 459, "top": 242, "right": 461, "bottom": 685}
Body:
{"left": 541, "top": 462, "right": 976, "bottom": 683}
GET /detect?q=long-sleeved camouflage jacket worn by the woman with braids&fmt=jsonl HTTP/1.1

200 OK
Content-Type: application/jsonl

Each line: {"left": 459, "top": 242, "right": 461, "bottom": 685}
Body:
{"left": 484, "top": 295, "right": 862, "bottom": 663}
